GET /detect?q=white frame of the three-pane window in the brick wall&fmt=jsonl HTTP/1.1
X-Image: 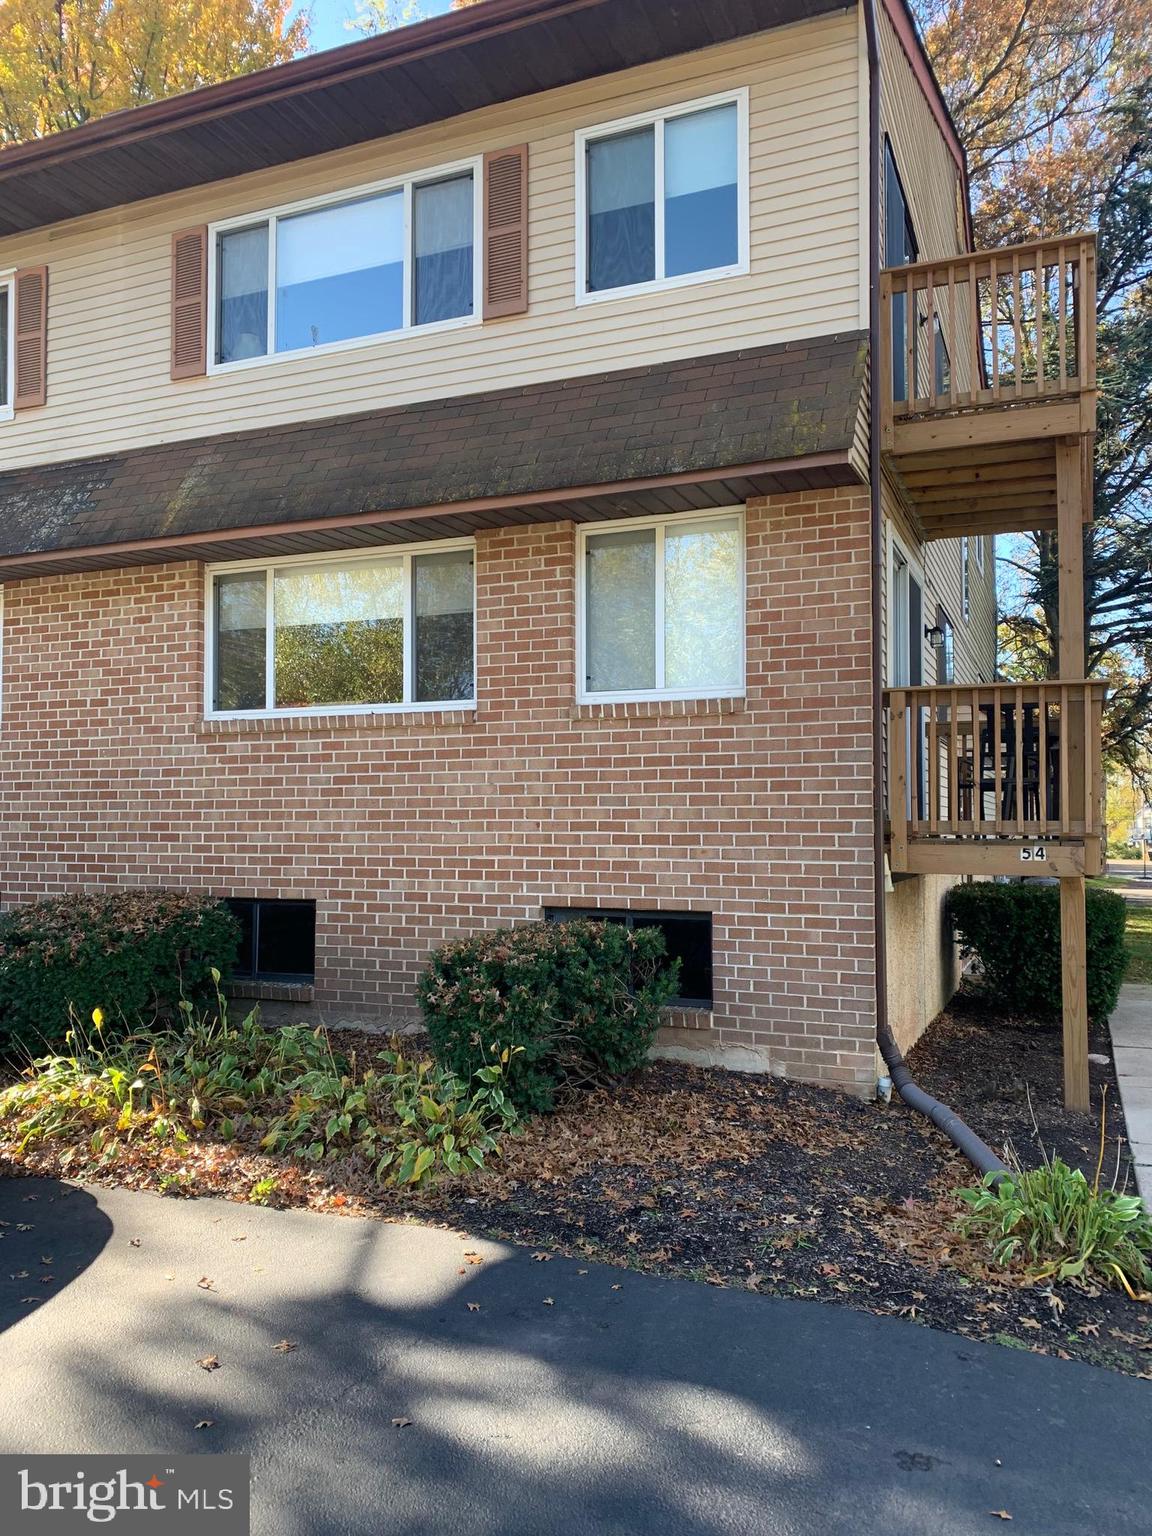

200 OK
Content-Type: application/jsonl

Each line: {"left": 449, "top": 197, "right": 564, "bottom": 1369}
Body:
{"left": 204, "top": 539, "right": 476, "bottom": 720}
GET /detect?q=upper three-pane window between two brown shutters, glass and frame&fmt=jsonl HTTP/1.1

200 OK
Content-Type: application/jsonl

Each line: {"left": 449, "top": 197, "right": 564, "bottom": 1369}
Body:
{"left": 209, "top": 163, "right": 479, "bottom": 369}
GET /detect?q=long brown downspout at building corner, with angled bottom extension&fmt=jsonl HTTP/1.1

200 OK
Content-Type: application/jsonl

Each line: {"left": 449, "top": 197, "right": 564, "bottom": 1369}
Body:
{"left": 862, "top": 0, "right": 1008, "bottom": 1174}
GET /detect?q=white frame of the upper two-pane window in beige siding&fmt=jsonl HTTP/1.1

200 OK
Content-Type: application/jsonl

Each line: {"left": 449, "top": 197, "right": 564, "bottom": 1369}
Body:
{"left": 576, "top": 86, "right": 750, "bottom": 304}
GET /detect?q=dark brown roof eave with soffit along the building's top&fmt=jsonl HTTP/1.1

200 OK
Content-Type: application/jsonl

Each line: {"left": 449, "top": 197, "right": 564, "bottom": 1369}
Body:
{"left": 0, "top": 0, "right": 845, "bottom": 235}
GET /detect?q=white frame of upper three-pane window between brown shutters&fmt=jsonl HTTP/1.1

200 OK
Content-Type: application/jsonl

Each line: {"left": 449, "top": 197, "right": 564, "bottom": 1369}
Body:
{"left": 207, "top": 155, "right": 484, "bottom": 373}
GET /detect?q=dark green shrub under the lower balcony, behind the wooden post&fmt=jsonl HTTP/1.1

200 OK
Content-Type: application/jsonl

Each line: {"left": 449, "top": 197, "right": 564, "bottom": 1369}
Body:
{"left": 948, "top": 880, "right": 1126, "bottom": 1020}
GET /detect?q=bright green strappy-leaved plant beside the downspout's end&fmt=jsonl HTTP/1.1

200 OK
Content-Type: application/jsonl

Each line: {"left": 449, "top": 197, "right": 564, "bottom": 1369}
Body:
{"left": 955, "top": 1157, "right": 1152, "bottom": 1296}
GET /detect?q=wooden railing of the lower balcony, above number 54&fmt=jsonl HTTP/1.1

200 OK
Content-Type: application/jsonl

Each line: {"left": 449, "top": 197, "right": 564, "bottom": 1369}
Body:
{"left": 885, "top": 682, "right": 1106, "bottom": 869}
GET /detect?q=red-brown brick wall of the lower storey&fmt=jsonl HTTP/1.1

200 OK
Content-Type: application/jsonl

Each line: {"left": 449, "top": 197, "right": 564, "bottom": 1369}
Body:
{"left": 0, "top": 490, "right": 874, "bottom": 1089}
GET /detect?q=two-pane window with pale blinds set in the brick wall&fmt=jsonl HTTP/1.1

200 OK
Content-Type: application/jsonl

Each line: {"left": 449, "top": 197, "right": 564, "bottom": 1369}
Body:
{"left": 578, "top": 511, "right": 745, "bottom": 700}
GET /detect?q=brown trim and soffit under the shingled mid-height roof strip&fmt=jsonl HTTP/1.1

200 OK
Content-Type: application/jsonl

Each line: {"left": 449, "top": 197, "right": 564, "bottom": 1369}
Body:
{"left": 0, "top": 450, "right": 860, "bottom": 581}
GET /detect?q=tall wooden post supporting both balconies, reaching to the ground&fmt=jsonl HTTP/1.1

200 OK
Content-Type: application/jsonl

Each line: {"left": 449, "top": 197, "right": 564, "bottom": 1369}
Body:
{"left": 1057, "top": 438, "right": 1092, "bottom": 1111}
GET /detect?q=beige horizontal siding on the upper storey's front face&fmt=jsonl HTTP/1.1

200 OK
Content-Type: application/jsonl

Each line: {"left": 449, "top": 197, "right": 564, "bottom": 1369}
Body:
{"left": 0, "top": 11, "right": 866, "bottom": 467}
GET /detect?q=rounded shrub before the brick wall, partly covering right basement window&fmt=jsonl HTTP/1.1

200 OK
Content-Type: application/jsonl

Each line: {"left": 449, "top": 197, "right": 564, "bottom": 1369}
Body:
{"left": 419, "top": 920, "right": 679, "bottom": 1112}
